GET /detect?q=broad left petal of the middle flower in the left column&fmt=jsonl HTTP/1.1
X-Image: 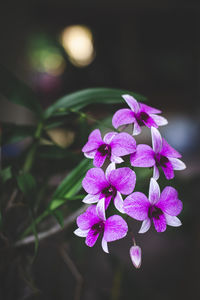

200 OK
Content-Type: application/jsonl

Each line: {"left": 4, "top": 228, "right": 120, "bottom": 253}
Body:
{"left": 82, "top": 168, "right": 108, "bottom": 195}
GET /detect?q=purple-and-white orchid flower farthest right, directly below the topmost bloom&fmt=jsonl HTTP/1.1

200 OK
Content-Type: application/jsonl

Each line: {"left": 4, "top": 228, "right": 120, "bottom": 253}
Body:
{"left": 130, "top": 127, "right": 186, "bottom": 180}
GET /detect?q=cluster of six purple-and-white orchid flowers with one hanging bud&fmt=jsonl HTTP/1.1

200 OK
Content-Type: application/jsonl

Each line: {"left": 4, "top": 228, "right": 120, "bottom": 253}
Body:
{"left": 74, "top": 95, "right": 185, "bottom": 268}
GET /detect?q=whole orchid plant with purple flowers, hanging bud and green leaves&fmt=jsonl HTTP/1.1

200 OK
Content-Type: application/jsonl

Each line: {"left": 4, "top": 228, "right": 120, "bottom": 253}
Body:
{"left": 0, "top": 72, "right": 185, "bottom": 274}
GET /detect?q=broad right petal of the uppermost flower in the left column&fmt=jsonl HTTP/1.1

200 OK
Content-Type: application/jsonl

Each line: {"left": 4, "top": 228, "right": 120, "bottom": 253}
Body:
{"left": 110, "top": 132, "right": 136, "bottom": 156}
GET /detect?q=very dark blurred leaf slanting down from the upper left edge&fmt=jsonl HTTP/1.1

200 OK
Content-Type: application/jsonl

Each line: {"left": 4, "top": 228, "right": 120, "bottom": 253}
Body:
{"left": 0, "top": 65, "right": 43, "bottom": 118}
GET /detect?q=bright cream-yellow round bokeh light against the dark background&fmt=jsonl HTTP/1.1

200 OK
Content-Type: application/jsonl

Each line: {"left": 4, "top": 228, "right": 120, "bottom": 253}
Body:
{"left": 61, "top": 25, "right": 95, "bottom": 67}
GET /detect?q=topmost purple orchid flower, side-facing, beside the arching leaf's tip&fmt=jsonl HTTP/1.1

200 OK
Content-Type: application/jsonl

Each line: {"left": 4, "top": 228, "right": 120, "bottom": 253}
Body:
{"left": 112, "top": 95, "right": 168, "bottom": 135}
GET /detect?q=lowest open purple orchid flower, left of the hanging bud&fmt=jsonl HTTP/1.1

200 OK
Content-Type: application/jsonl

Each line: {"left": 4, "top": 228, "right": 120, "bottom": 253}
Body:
{"left": 74, "top": 201, "right": 128, "bottom": 253}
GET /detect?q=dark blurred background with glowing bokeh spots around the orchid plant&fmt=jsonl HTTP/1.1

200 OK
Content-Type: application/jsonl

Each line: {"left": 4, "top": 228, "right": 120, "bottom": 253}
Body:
{"left": 0, "top": 0, "right": 200, "bottom": 300}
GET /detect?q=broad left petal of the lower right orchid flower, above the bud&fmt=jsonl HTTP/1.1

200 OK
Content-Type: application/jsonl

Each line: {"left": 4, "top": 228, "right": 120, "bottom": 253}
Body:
{"left": 124, "top": 192, "right": 150, "bottom": 221}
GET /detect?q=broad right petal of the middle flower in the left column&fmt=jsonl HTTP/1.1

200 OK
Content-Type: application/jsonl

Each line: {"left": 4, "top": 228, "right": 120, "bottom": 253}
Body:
{"left": 109, "top": 167, "right": 136, "bottom": 195}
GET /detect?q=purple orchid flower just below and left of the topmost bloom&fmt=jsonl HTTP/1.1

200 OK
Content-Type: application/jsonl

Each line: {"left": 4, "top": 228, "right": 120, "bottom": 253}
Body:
{"left": 82, "top": 129, "right": 136, "bottom": 167}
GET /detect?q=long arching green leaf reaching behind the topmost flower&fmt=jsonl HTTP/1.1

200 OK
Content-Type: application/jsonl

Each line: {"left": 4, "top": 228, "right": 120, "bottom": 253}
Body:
{"left": 45, "top": 88, "right": 146, "bottom": 118}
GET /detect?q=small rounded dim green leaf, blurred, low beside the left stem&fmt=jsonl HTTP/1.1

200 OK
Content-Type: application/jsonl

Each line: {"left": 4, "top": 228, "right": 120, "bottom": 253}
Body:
{"left": 17, "top": 173, "right": 36, "bottom": 196}
